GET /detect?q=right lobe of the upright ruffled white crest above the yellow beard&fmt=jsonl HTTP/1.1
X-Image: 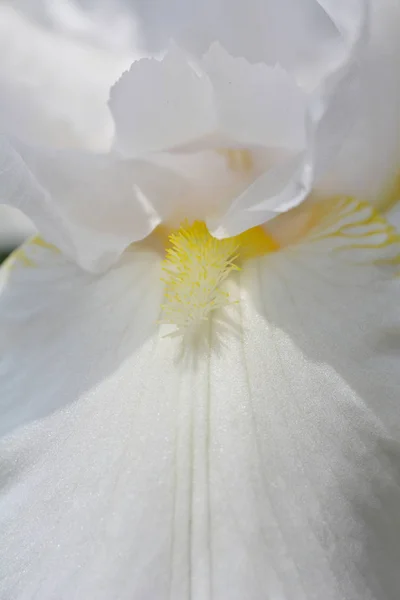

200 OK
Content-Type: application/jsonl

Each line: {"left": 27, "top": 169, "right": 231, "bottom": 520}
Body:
{"left": 201, "top": 43, "right": 308, "bottom": 149}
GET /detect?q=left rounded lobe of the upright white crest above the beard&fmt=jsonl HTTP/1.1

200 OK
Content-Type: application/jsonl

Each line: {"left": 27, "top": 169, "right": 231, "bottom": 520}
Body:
{"left": 110, "top": 46, "right": 216, "bottom": 156}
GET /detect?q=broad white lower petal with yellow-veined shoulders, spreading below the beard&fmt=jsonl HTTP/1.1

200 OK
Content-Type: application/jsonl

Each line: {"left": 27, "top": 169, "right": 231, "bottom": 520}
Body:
{"left": 0, "top": 201, "right": 400, "bottom": 600}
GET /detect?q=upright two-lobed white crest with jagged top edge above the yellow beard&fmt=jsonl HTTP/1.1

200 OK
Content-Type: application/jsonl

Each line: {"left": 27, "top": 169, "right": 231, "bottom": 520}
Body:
{"left": 110, "top": 43, "right": 308, "bottom": 156}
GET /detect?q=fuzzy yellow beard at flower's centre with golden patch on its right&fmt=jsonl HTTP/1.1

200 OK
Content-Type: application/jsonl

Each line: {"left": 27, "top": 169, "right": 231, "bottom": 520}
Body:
{"left": 161, "top": 221, "right": 277, "bottom": 335}
